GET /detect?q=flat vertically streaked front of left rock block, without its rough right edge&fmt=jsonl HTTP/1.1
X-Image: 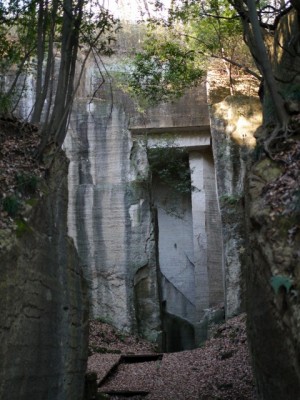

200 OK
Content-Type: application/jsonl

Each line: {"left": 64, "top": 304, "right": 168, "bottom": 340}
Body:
{"left": 66, "top": 100, "right": 130, "bottom": 327}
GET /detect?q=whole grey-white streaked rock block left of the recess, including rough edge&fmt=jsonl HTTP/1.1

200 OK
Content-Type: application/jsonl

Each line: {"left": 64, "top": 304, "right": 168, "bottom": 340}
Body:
{"left": 65, "top": 91, "right": 160, "bottom": 340}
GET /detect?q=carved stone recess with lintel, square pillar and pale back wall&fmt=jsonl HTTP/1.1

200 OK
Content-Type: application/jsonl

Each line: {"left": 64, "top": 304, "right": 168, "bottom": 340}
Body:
{"left": 131, "top": 98, "right": 224, "bottom": 348}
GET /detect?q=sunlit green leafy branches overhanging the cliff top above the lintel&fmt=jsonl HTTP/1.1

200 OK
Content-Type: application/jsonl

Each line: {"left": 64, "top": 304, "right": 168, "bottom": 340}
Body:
{"left": 129, "top": 0, "right": 253, "bottom": 104}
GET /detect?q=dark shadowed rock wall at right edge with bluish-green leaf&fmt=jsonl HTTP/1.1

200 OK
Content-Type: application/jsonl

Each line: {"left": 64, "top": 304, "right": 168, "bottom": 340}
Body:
{"left": 246, "top": 155, "right": 300, "bottom": 400}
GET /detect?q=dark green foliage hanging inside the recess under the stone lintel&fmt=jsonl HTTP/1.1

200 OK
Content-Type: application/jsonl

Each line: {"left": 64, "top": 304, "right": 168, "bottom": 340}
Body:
{"left": 148, "top": 147, "right": 192, "bottom": 193}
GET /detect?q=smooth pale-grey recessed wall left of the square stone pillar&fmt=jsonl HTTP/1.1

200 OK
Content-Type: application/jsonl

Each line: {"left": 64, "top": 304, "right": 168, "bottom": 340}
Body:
{"left": 152, "top": 181, "right": 195, "bottom": 304}
